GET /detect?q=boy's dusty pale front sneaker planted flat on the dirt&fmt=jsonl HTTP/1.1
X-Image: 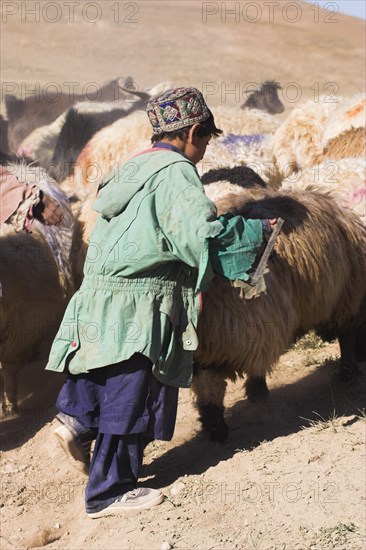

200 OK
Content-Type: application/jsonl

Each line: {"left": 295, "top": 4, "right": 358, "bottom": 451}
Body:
{"left": 87, "top": 487, "right": 164, "bottom": 519}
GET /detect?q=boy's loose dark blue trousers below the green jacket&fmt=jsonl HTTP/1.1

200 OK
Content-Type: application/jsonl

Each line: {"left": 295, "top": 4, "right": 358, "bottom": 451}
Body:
{"left": 56, "top": 353, "right": 178, "bottom": 512}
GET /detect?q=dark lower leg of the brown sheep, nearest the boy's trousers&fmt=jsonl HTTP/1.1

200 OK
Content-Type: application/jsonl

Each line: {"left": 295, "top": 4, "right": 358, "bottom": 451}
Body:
{"left": 192, "top": 367, "right": 229, "bottom": 442}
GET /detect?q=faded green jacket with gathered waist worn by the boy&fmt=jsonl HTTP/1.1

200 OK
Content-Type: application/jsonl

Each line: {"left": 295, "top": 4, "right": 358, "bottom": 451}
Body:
{"left": 46, "top": 150, "right": 262, "bottom": 387}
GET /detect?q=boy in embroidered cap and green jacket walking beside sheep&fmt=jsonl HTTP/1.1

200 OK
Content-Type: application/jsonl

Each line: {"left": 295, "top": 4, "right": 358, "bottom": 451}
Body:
{"left": 47, "top": 88, "right": 274, "bottom": 518}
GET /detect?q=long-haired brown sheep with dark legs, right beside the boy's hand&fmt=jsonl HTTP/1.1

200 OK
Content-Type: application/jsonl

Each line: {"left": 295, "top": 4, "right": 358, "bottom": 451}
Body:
{"left": 192, "top": 184, "right": 366, "bottom": 441}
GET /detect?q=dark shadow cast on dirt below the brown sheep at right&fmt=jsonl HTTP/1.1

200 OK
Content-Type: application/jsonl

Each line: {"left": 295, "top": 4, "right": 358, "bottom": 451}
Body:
{"left": 141, "top": 360, "right": 366, "bottom": 488}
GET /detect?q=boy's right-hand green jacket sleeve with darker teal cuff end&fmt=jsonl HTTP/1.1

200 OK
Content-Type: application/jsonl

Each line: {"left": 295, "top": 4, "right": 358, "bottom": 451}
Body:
{"left": 157, "top": 162, "right": 262, "bottom": 291}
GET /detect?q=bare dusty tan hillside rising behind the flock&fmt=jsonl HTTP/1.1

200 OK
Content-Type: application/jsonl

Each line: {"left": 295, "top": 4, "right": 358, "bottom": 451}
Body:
{"left": 1, "top": 0, "right": 365, "bottom": 108}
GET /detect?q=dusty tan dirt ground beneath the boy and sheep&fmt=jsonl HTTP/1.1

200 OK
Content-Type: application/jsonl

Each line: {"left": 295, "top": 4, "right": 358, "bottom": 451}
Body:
{"left": 0, "top": 344, "right": 366, "bottom": 550}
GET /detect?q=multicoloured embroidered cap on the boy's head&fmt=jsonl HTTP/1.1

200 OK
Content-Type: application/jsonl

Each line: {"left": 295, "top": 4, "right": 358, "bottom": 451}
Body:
{"left": 146, "top": 87, "right": 210, "bottom": 134}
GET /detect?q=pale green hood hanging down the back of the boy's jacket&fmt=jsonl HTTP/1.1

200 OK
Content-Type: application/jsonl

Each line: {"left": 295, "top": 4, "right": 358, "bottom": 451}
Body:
{"left": 93, "top": 149, "right": 194, "bottom": 219}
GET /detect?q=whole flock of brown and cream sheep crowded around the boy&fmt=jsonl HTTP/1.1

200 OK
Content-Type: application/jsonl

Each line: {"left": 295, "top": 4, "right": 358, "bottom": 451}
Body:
{"left": 0, "top": 77, "right": 366, "bottom": 441}
